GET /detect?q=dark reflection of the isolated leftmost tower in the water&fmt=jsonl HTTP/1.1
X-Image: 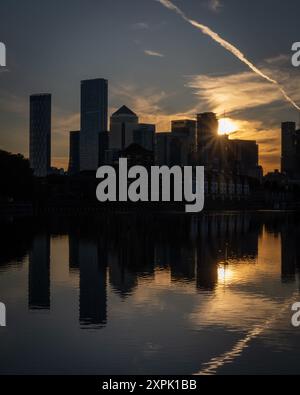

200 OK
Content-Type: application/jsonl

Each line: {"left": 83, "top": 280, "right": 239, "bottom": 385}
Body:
{"left": 29, "top": 234, "right": 50, "bottom": 310}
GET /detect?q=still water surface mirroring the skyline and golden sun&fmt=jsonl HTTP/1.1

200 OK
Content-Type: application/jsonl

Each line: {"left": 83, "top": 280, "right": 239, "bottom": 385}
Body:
{"left": 0, "top": 212, "right": 300, "bottom": 375}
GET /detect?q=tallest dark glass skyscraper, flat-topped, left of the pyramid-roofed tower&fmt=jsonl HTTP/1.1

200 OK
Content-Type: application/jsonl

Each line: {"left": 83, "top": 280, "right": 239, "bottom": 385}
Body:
{"left": 80, "top": 78, "right": 108, "bottom": 171}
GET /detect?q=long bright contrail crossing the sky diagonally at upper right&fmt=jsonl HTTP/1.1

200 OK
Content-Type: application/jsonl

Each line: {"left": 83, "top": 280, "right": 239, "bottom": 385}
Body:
{"left": 157, "top": 0, "right": 300, "bottom": 111}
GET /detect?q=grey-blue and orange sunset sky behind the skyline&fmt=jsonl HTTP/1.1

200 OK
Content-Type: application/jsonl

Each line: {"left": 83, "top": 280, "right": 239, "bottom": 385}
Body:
{"left": 0, "top": 0, "right": 300, "bottom": 171}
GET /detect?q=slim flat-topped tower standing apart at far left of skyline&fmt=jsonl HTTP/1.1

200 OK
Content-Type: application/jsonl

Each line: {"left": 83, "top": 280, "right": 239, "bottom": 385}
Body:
{"left": 29, "top": 94, "right": 51, "bottom": 177}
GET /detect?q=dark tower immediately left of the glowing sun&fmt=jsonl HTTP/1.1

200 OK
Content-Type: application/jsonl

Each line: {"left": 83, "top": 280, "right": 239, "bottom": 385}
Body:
{"left": 197, "top": 112, "right": 219, "bottom": 168}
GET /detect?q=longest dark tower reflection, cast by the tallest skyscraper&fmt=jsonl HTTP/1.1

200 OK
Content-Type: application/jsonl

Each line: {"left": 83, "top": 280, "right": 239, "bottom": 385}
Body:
{"left": 78, "top": 239, "right": 107, "bottom": 326}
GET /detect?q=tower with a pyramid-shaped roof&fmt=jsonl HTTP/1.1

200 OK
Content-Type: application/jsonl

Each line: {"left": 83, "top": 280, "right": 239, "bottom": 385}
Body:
{"left": 109, "top": 106, "right": 139, "bottom": 151}
